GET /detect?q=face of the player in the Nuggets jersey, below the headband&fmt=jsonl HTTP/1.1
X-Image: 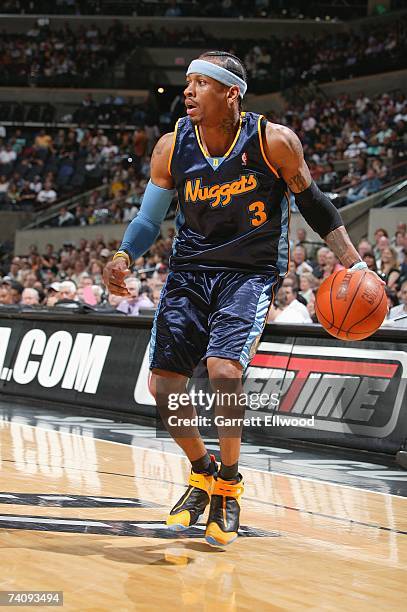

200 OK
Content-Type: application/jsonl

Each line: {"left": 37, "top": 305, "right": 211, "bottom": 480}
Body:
{"left": 184, "top": 73, "right": 228, "bottom": 125}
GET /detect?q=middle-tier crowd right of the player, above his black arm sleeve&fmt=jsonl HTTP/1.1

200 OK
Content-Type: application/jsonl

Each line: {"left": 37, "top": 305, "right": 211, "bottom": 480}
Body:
{"left": 271, "top": 92, "right": 407, "bottom": 205}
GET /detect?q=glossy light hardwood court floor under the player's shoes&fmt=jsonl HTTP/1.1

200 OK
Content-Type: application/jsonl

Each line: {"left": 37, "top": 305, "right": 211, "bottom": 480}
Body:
{"left": 0, "top": 421, "right": 407, "bottom": 612}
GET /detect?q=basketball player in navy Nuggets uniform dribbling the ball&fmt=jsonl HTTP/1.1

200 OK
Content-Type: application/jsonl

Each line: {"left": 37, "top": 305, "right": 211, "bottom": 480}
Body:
{"left": 104, "top": 51, "right": 366, "bottom": 546}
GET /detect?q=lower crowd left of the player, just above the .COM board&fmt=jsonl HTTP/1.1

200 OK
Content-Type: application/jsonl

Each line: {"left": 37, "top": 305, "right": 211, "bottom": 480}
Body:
{"left": 0, "top": 234, "right": 174, "bottom": 315}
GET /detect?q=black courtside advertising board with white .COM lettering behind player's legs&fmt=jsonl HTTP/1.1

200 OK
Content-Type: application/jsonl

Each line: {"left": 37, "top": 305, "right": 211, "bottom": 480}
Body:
{"left": 0, "top": 314, "right": 407, "bottom": 454}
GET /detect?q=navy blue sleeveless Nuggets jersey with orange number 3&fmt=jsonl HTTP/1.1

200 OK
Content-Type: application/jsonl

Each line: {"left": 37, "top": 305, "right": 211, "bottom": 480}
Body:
{"left": 169, "top": 113, "right": 289, "bottom": 275}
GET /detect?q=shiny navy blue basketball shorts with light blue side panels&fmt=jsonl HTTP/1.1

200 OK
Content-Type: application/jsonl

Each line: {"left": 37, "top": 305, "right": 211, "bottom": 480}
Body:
{"left": 150, "top": 270, "right": 279, "bottom": 378}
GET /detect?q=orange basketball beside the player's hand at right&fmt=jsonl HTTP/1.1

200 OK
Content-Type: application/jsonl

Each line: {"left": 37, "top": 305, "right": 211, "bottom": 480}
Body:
{"left": 315, "top": 270, "right": 387, "bottom": 340}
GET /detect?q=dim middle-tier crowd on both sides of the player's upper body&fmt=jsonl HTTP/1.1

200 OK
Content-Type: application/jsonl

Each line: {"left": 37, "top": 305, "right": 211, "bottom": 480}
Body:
{"left": 0, "top": 86, "right": 407, "bottom": 218}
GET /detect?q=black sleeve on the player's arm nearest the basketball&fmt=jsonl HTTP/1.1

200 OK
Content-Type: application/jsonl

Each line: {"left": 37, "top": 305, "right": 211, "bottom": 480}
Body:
{"left": 294, "top": 181, "right": 343, "bottom": 238}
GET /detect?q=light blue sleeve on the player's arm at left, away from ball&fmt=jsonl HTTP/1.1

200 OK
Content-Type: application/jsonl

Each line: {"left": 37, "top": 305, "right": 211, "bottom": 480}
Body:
{"left": 119, "top": 181, "right": 175, "bottom": 261}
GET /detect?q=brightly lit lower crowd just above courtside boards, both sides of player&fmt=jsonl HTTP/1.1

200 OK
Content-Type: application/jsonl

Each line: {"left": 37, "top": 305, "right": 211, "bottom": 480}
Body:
{"left": 0, "top": 222, "right": 407, "bottom": 326}
